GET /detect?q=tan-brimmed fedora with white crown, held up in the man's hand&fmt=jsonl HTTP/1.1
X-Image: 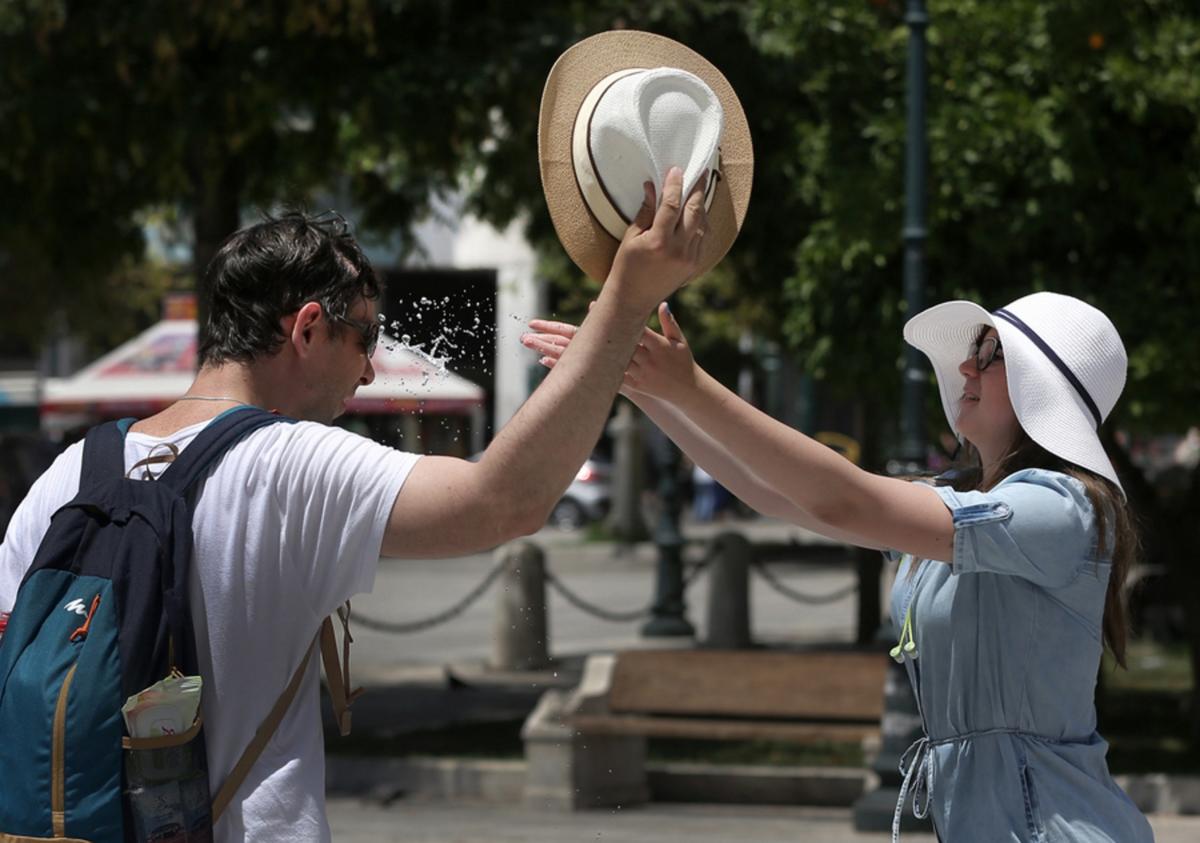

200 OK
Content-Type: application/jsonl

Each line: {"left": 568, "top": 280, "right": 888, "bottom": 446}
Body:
{"left": 538, "top": 30, "right": 754, "bottom": 281}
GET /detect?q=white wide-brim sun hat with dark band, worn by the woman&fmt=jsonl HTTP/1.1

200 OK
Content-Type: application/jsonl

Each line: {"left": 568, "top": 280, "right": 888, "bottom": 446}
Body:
{"left": 904, "top": 293, "right": 1128, "bottom": 494}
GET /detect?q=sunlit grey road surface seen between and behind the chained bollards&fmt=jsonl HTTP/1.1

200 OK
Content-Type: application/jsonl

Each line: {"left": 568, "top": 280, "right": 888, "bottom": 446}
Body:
{"left": 353, "top": 520, "right": 856, "bottom": 684}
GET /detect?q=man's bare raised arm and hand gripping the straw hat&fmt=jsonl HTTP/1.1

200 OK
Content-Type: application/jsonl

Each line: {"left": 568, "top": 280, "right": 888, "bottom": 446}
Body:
{"left": 383, "top": 168, "right": 707, "bottom": 557}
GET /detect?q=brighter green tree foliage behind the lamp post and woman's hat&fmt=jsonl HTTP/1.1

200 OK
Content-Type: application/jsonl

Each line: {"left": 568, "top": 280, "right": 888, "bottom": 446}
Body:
{"left": 755, "top": 0, "right": 1200, "bottom": 428}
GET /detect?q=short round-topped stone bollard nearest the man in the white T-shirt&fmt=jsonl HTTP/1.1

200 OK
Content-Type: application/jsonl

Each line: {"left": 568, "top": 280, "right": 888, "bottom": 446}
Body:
{"left": 491, "top": 542, "right": 550, "bottom": 670}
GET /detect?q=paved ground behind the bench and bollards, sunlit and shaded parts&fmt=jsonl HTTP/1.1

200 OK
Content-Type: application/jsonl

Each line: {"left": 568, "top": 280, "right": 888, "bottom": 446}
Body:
{"left": 336, "top": 519, "right": 873, "bottom": 739}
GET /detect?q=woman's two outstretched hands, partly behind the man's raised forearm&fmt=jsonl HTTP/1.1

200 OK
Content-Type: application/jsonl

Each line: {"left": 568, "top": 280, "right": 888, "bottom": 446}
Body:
{"left": 521, "top": 301, "right": 697, "bottom": 403}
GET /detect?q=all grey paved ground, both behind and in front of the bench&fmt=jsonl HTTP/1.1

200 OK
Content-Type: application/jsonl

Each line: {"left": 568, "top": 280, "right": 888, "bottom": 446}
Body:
{"left": 329, "top": 521, "right": 1200, "bottom": 843}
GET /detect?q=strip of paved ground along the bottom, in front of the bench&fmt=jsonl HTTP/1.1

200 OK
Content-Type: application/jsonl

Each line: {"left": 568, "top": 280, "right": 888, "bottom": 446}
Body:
{"left": 329, "top": 800, "right": 1200, "bottom": 843}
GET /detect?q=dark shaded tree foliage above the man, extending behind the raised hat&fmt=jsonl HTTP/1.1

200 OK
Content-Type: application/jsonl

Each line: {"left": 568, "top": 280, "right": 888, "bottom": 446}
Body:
{"left": 0, "top": 0, "right": 796, "bottom": 367}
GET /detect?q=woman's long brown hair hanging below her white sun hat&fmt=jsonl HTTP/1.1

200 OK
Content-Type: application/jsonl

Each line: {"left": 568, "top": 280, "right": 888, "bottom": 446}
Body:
{"left": 950, "top": 428, "right": 1140, "bottom": 668}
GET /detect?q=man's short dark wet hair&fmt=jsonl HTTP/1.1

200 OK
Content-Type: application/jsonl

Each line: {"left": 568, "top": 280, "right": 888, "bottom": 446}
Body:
{"left": 199, "top": 211, "right": 379, "bottom": 366}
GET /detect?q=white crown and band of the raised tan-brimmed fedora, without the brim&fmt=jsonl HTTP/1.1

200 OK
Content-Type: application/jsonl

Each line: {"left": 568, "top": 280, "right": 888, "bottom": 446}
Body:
{"left": 571, "top": 67, "right": 725, "bottom": 240}
